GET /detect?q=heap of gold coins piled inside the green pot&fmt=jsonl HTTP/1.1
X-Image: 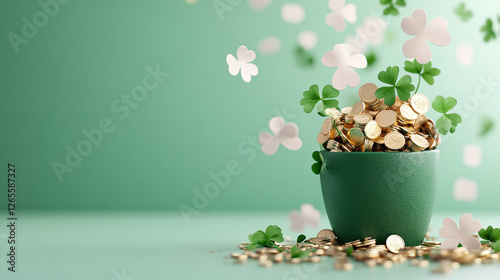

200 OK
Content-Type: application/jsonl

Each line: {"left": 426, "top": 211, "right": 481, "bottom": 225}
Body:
{"left": 318, "top": 83, "right": 441, "bottom": 152}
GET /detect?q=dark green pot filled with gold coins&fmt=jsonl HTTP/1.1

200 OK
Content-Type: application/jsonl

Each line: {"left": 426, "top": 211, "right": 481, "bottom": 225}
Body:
{"left": 320, "top": 150, "right": 439, "bottom": 246}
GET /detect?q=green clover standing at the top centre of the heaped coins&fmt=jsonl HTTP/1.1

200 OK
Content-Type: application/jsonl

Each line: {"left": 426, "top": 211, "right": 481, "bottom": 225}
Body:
{"left": 375, "top": 66, "right": 415, "bottom": 105}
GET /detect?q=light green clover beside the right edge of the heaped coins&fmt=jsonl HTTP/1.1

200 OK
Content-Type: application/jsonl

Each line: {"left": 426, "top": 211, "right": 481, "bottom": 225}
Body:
{"left": 432, "top": 95, "right": 462, "bottom": 135}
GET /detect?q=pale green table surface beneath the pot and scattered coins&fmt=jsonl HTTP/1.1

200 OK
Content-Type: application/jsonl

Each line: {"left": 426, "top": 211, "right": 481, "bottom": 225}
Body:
{"left": 0, "top": 211, "right": 500, "bottom": 280}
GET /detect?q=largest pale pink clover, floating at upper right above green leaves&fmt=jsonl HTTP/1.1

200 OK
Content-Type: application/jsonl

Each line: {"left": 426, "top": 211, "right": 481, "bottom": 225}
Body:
{"left": 401, "top": 9, "right": 451, "bottom": 64}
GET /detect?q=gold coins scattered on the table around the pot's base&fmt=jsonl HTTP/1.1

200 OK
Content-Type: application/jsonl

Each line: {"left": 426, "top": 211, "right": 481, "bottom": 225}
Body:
{"left": 231, "top": 229, "right": 500, "bottom": 273}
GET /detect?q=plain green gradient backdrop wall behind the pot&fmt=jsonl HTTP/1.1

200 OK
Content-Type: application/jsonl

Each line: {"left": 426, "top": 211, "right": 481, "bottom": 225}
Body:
{"left": 0, "top": 0, "right": 500, "bottom": 211}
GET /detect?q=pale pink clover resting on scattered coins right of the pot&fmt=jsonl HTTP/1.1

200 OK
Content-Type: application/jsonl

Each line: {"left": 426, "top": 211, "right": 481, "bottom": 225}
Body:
{"left": 439, "top": 213, "right": 481, "bottom": 250}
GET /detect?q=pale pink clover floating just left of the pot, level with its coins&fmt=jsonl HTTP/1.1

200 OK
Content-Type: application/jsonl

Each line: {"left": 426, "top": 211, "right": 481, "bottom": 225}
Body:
{"left": 259, "top": 117, "right": 302, "bottom": 155}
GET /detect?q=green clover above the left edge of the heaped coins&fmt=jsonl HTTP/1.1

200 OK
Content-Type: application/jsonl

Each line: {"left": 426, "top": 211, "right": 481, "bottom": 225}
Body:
{"left": 300, "top": 85, "right": 339, "bottom": 113}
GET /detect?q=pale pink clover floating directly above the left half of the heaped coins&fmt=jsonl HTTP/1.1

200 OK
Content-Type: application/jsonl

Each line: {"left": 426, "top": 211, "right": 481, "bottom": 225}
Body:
{"left": 321, "top": 44, "right": 367, "bottom": 90}
